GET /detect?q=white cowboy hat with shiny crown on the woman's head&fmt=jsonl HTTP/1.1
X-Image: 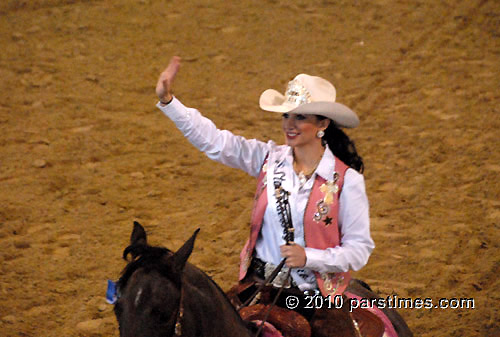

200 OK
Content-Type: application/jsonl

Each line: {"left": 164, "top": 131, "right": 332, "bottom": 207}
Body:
{"left": 259, "top": 74, "right": 359, "bottom": 128}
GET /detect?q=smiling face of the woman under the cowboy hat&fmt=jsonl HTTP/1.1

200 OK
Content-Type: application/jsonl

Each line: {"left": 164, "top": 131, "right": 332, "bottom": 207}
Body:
{"left": 282, "top": 113, "right": 329, "bottom": 148}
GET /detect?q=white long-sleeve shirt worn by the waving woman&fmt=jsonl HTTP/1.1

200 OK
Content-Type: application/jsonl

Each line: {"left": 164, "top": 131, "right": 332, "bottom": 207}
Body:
{"left": 157, "top": 97, "right": 375, "bottom": 289}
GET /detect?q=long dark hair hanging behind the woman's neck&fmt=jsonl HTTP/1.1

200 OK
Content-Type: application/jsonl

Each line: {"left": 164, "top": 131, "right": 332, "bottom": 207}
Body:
{"left": 317, "top": 116, "right": 365, "bottom": 173}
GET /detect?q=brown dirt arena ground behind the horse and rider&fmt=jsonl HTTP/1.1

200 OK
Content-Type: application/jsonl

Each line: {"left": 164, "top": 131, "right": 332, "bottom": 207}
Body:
{"left": 0, "top": 0, "right": 500, "bottom": 336}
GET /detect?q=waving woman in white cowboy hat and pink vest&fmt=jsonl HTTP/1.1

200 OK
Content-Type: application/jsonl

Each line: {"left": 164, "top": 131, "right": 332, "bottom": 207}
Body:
{"left": 156, "top": 57, "right": 374, "bottom": 297}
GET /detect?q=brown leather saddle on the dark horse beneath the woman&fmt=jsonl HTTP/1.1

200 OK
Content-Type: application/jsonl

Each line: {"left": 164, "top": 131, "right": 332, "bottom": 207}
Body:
{"left": 227, "top": 280, "right": 384, "bottom": 337}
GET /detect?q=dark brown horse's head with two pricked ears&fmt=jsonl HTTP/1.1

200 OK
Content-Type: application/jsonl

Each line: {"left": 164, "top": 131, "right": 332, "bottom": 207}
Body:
{"left": 115, "top": 222, "right": 199, "bottom": 337}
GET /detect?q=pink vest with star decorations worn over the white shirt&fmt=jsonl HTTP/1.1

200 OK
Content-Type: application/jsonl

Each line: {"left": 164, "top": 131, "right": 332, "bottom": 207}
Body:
{"left": 239, "top": 158, "right": 351, "bottom": 301}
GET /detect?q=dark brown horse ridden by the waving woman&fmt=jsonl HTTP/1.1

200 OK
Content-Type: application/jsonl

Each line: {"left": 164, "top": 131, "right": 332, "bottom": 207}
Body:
{"left": 114, "top": 222, "right": 412, "bottom": 337}
